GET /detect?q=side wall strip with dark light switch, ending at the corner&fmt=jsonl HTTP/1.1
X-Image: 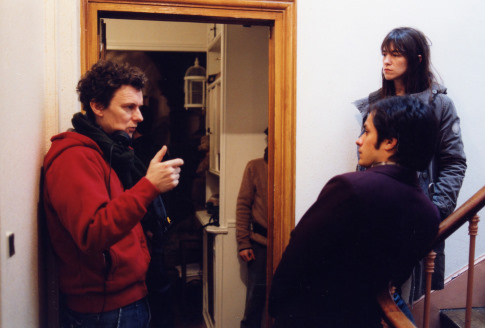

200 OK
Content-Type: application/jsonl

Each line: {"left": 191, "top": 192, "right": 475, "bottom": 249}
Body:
{"left": 0, "top": 0, "right": 44, "bottom": 327}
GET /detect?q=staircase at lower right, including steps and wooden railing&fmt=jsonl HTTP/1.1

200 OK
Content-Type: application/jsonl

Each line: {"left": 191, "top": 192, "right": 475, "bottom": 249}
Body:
{"left": 376, "top": 186, "right": 485, "bottom": 328}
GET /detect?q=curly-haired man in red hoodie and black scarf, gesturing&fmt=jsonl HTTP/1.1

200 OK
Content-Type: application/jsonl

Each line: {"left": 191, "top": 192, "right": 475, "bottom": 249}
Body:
{"left": 44, "top": 61, "right": 183, "bottom": 328}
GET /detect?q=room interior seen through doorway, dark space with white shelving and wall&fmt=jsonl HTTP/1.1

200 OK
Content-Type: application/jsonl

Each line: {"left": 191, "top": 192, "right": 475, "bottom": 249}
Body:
{"left": 101, "top": 19, "right": 269, "bottom": 327}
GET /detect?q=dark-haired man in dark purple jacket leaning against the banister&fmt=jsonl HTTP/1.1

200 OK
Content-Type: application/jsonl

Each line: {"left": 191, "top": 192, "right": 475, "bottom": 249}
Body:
{"left": 269, "top": 97, "right": 440, "bottom": 328}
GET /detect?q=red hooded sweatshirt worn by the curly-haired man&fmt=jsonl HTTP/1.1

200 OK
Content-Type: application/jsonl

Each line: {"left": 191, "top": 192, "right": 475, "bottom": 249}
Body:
{"left": 44, "top": 132, "right": 158, "bottom": 313}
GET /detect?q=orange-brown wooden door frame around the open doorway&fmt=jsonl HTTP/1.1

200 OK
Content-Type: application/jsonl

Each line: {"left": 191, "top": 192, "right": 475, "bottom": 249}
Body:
{"left": 81, "top": 0, "right": 296, "bottom": 288}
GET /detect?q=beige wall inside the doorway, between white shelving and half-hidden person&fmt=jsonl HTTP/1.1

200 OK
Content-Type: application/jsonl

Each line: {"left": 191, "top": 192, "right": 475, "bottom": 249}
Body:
{"left": 219, "top": 25, "right": 269, "bottom": 327}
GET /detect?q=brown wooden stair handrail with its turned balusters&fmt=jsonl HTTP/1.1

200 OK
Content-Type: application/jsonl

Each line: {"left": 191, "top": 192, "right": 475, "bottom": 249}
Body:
{"left": 377, "top": 186, "right": 485, "bottom": 328}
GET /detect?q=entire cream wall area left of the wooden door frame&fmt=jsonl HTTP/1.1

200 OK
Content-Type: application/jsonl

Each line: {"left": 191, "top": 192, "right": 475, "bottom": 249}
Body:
{"left": 0, "top": 0, "right": 80, "bottom": 327}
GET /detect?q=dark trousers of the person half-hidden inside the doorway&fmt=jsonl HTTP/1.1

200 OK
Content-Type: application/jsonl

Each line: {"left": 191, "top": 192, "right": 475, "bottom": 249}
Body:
{"left": 241, "top": 242, "right": 266, "bottom": 328}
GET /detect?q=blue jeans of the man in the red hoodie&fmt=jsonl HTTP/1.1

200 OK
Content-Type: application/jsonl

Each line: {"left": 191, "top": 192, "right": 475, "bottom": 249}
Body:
{"left": 61, "top": 299, "right": 150, "bottom": 328}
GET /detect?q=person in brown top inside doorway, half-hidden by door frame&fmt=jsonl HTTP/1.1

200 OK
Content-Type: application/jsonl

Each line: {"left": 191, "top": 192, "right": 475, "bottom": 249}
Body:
{"left": 236, "top": 129, "right": 268, "bottom": 328}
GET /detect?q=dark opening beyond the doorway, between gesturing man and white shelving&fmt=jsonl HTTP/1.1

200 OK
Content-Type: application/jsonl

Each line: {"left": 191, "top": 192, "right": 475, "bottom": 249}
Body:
{"left": 103, "top": 45, "right": 206, "bottom": 328}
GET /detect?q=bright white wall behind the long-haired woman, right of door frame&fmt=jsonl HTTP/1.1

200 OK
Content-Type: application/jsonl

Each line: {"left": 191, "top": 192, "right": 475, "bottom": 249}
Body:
{"left": 296, "top": 0, "right": 485, "bottom": 275}
